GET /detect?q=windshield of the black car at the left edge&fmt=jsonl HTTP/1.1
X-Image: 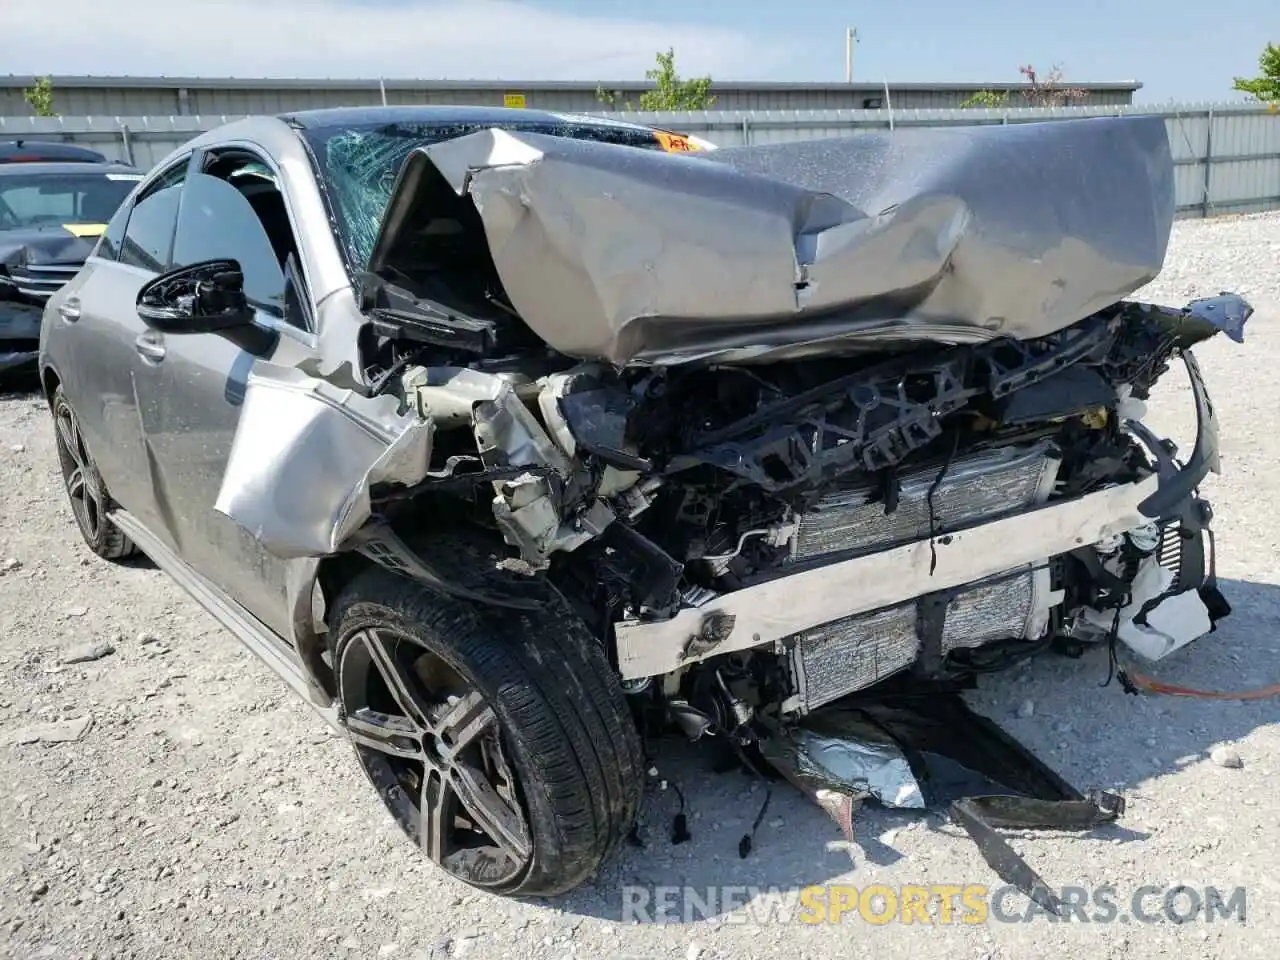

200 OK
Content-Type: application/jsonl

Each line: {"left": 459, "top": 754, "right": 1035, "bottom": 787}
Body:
{"left": 0, "top": 173, "right": 141, "bottom": 230}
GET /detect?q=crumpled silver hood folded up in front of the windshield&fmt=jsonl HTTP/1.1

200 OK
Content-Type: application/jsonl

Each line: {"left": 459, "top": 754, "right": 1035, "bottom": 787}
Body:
{"left": 370, "top": 116, "right": 1174, "bottom": 365}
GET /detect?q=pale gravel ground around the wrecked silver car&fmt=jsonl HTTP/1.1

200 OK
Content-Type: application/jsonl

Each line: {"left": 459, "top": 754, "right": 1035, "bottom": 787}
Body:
{"left": 0, "top": 215, "right": 1280, "bottom": 960}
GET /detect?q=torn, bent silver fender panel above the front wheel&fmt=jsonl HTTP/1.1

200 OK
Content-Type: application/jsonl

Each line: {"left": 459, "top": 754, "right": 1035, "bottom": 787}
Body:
{"left": 214, "top": 362, "right": 433, "bottom": 559}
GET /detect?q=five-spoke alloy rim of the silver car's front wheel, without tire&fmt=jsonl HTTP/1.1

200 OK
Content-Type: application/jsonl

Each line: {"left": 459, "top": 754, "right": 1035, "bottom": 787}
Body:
{"left": 338, "top": 627, "right": 532, "bottom": 887}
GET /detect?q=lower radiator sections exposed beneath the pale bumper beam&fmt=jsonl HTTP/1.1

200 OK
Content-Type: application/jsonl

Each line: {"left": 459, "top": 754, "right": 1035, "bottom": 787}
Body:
{"left": 783, "top": 567, "right": 1062, "bottom": 713}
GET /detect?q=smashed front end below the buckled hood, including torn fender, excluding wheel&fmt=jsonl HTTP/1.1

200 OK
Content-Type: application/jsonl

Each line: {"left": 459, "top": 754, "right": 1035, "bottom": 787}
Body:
{"left": 216, "top": 294, "right": 1251, "bottom": 696}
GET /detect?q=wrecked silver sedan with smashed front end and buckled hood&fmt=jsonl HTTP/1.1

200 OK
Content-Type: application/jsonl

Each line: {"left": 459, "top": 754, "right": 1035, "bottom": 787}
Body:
{"left": 41, "top": 108, "right": 1252, "bottom": 895}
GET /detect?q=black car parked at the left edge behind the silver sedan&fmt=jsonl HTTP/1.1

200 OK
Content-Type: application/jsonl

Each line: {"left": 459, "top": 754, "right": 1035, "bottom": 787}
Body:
{"left": 0, "top": 148, "right": 142, "bottom": 374}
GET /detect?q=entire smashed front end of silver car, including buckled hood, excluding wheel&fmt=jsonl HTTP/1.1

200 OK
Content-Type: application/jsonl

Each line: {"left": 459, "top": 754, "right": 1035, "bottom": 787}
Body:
{"left": 207, "top": 123, "right": 1252, "bottom": 744}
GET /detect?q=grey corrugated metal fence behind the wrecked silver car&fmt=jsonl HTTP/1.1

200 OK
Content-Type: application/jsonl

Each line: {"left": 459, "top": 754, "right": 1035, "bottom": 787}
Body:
{"left": 0, "top": 102, "right": 1280, "bottom": 216}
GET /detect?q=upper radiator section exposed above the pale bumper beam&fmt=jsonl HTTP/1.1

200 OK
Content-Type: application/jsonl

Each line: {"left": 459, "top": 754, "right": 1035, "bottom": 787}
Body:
{"left": 791, "top": 443, "right": 1059, "bottom": 562}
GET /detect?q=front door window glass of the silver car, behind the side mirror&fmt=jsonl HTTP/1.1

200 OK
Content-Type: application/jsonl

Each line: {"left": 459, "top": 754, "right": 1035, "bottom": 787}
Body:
{"left": 173, "top": 173, "right": 285, "bottom": 316}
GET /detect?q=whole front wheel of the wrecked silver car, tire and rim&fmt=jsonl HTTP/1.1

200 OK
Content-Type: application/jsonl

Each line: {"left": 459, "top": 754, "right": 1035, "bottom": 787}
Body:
{"left": 329, "top": 568, "right": 644, "bottom": 896}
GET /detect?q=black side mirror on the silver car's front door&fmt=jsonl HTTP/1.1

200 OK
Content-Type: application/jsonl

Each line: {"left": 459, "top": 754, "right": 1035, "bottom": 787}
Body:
{"left": 137, "top": 260, "right": 255, "bottom": 334}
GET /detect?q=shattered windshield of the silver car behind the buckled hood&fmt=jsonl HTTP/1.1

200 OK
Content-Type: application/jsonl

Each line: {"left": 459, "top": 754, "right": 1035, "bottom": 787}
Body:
{"left": 301, "top": 120, "right": 662, "bottom": 269}
